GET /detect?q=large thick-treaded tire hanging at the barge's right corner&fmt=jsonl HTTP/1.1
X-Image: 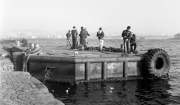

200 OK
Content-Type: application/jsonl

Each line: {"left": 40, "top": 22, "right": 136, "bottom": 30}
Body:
{"left": 145, "top": 49, "right": 170, "bottom": 79}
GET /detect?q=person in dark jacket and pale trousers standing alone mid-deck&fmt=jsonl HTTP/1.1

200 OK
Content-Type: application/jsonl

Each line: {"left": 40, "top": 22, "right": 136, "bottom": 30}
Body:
{"left": 97, "top": 27, "right": 104, "bottom": 51}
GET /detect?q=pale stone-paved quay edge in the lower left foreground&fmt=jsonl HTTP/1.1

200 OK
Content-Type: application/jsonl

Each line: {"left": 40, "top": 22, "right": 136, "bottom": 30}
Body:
{"left": 0, "top": 41, "right": 64, "bottom": 105}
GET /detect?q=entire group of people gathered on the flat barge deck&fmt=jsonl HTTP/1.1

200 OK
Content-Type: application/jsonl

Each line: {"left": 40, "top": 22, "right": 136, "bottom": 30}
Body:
{"left": 66, "top": 26, "right": 137, "bottom": 53}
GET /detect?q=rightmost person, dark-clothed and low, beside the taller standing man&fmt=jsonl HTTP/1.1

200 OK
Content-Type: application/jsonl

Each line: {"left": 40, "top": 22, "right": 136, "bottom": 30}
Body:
{"left": 130, "top": 34, "right": 137, "bottom": 53}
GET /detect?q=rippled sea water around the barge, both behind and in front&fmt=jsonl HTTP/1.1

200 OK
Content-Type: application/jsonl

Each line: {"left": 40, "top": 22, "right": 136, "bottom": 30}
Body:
{"left": 29, "top": 39, "right": 180, "bottom": 105}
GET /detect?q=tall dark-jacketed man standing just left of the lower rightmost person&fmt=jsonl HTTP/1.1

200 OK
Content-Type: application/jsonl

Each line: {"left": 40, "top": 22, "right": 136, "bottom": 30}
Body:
{"left": 122, "top": 26, "right": 131, "bottom": 53}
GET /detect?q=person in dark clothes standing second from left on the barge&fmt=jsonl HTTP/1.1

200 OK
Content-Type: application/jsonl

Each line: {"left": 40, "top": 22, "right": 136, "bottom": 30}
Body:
{"left": 71, "top": 26, "right": 78, "bottom": 49}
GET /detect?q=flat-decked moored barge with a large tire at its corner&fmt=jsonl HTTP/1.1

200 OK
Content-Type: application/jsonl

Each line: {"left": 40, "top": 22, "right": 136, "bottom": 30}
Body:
{"left": 7, "top": 46, "right": 170, "bottom": 83}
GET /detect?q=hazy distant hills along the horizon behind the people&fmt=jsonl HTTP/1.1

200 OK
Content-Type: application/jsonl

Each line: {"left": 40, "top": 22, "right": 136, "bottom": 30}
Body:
{"left": 0, "top": 30, "right": 174, "bottom": 39}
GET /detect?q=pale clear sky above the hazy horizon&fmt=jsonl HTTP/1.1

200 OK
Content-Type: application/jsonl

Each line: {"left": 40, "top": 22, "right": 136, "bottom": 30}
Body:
{"left": 0, "top": 0, "right": 180, "bottom": 35}
